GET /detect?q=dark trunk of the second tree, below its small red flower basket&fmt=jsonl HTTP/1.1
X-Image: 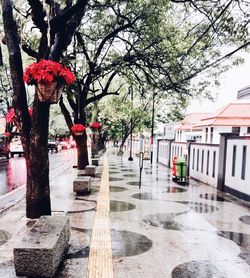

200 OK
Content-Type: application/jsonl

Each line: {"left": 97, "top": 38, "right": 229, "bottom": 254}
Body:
{"left": 75, "top": 131, "right": 89, "bottom": 170}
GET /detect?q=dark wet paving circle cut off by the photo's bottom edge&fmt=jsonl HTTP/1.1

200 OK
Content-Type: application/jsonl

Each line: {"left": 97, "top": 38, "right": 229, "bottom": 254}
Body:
{"left": 172, "top": 261, "right": 226, "bottom": 278}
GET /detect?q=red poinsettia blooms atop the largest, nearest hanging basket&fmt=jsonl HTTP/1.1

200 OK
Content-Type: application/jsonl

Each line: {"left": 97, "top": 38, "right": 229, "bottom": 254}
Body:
{"left": 23, "top": 60, "right": 76, "bottom": 85}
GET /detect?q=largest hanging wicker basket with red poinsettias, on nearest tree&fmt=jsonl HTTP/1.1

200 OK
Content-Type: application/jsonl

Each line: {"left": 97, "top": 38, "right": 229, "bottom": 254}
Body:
{"left": 23, "top": 60, "right": 75, "bottom": 104}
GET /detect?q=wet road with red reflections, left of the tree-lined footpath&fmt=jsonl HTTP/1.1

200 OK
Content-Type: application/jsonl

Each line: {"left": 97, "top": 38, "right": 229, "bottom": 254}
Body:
{"left": 0, "top": 149, "right": 76, "bottom": 197}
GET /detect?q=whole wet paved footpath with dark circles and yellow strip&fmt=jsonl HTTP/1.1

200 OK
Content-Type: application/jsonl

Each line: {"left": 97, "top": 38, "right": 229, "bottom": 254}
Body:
{"left": 0, "top": 147, "right": 250, "bottom": 278}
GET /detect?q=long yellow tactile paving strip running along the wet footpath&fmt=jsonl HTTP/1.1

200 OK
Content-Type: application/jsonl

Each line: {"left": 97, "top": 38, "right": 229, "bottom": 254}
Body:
{"left": 87, "top": 155, "right": 114, "bottom": 278}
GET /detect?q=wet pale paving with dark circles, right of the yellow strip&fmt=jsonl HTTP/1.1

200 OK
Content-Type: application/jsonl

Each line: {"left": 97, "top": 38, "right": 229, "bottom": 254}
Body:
{"left": 108, "top": 153, "right": 250, "bottom": 278}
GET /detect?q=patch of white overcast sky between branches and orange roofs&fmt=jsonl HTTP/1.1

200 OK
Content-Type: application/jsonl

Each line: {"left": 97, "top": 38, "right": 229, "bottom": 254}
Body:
{"left": 187, "top": 54, "right": 250, "bottom": 113}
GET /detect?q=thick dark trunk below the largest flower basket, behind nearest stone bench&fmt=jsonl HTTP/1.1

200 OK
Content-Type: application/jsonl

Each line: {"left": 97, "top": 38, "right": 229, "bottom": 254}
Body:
{"left": 26, "top": 100, "right": 51, "bottom": 218}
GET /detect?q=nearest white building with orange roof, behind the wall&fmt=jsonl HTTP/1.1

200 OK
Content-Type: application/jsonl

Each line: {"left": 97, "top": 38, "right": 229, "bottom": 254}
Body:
{"left": 194, "top": 101, "right": 250, "bottom": 144}
